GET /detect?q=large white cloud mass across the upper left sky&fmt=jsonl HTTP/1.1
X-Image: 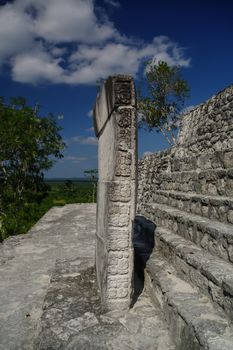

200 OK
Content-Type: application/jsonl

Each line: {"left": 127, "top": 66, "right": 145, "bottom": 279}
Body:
{"left": 0, "top": 0, "right": 190, "bottom": 85}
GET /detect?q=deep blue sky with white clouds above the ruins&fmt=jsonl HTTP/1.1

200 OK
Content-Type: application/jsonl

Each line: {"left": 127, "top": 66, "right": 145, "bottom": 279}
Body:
{"left": 0, "top": 0, "right": 233, "bottom": 177}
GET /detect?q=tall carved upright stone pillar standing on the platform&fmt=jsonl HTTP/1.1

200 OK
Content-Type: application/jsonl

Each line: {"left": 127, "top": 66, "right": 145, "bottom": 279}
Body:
{"left": 93, "top": 75, "right": 137, "bottom": 310}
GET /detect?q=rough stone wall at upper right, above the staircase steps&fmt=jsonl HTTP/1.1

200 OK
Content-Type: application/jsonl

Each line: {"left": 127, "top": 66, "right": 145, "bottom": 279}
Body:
{"left": 178, "top": 86, "right": 233, "bottom": 155}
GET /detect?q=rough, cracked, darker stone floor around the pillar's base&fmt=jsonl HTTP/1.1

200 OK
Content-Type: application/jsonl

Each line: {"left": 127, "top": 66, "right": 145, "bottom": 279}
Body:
{"left": 34, "top": 254, "right": 174, "bottom": 350}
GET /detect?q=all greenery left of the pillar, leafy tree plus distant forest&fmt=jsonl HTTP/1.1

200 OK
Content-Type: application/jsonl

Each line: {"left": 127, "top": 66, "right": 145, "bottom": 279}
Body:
{"left": 0, "top": 97, "right": 97, "bottom": 241}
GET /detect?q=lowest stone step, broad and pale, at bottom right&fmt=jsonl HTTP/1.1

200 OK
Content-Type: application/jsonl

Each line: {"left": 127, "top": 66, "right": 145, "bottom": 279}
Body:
{"left": 145, "top": 256, "right": 233, "bottom": 350}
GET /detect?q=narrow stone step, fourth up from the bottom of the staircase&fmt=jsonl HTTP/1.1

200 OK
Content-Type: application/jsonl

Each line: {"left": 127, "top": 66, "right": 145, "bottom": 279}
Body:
{"left": 152, "top": 190, "right": 233, "bottom": 224}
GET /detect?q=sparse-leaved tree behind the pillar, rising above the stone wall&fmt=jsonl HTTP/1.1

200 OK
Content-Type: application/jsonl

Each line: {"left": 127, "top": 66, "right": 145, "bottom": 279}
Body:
{"left": 138, "top": 61, "right": 189, "bottom": 145}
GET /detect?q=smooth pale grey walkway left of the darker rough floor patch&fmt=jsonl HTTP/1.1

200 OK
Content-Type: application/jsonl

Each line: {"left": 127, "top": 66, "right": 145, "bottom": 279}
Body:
{"left": 0, "top": 204, "right": 96, "bottom": 350}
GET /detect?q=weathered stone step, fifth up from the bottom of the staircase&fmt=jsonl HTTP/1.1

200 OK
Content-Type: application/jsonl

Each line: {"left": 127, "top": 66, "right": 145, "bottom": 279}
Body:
{"left": 153, "top": 168, "right": 233, "bottom": 197}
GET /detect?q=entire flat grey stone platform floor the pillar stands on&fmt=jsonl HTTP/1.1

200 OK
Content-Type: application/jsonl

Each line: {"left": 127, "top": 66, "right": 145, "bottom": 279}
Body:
{"left": 0, "top": 204, "right": 174, "bottom": 350}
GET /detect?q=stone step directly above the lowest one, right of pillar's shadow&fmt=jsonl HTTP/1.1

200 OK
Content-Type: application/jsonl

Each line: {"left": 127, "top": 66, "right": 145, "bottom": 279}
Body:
{"left": 155, "top": 229, "right": 233, "bottom": 320}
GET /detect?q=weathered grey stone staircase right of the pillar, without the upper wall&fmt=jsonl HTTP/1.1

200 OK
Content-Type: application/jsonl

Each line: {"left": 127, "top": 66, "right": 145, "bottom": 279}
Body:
{"left": 134, "top": 149, "right": 233, "bottom": 350}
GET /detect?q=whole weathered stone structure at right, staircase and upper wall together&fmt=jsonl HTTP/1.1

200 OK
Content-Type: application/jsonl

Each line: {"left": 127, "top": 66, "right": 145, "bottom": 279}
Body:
{"left": 136, "top": 86, "right": 233, "bottom": 350}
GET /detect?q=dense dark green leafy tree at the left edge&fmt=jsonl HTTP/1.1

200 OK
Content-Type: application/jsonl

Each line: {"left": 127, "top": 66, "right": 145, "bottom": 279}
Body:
{"left": 0, "top": 97, "right": 65, "bottom": 238}
